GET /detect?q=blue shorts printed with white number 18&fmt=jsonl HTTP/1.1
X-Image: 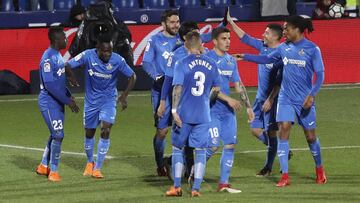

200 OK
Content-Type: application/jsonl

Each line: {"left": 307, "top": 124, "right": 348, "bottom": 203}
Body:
{"left": 208, "top": 112, "right": 237, "bottom": 147}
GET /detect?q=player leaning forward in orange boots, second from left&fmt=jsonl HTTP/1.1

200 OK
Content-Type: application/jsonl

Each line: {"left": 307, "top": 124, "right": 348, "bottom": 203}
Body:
{"left": 66, "top": 35, "right": 136, "bottom": 178}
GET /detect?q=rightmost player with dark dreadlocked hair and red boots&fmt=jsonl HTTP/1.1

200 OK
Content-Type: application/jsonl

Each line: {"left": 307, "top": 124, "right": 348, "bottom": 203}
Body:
{"left": 242, "top": 16, "right": 327, "bottom": 187}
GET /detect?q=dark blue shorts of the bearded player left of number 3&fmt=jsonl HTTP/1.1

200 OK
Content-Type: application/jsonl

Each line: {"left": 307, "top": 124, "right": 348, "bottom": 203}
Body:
{"left": 151, "top": 89, "right": 172, "bottom": 129}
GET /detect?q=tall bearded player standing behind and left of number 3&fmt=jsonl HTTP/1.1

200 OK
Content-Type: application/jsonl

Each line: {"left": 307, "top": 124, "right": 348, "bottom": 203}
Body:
{"left": 142, "top": 10, "right": 218, "bottom": 177}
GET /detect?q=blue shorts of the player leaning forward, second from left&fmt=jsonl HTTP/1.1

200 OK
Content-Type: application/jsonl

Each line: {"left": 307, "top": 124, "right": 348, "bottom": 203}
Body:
{"left": 84, "top": 99, "right": 116, "bottom": 129}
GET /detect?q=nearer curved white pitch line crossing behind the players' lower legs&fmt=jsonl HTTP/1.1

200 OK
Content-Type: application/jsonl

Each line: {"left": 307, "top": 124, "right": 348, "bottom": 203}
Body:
{"left": 0, "top": 144, "right": 360, "bottom": 159}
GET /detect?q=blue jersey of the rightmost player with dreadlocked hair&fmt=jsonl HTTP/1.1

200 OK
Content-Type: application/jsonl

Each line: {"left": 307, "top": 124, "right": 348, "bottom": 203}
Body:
{"left": 269, "top": 38, "right": 324, "bottom": 105}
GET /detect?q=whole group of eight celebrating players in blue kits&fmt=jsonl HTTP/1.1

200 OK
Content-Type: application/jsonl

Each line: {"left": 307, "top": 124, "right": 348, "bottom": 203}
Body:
{"left": 36, "top": 7, "right": 326, "bottom": 197}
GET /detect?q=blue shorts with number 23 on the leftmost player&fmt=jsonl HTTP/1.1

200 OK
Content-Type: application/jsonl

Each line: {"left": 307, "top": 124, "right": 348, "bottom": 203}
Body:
{"left": 41, "top": 108, "right": 64, "bottom": 138}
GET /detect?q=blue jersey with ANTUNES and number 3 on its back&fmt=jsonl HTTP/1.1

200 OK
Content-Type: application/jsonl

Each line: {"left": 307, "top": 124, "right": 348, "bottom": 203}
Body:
{"left": 173, "top": 54, "right": 220, "bottom": 124}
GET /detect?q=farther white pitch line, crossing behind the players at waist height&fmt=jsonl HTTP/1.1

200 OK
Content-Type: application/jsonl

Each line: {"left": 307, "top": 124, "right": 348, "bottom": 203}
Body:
{"left": 0, "top": 83, "right": 360, "bottom": 103}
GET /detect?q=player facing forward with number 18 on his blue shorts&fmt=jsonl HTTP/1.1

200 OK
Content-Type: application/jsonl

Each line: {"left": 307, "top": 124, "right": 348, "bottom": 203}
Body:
{"left": 206, "top": 28, "right": 254, "bottom": 193}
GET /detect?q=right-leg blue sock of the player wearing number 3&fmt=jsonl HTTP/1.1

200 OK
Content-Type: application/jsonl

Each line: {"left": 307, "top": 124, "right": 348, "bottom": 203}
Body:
{"left": 192, "top": 149, "right": 206, "bottom": 191}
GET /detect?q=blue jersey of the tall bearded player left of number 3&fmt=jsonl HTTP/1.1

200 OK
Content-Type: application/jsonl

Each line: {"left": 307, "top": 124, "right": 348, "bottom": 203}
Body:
{"left": 143, "top": 32, "right": 182, "bottom": 76}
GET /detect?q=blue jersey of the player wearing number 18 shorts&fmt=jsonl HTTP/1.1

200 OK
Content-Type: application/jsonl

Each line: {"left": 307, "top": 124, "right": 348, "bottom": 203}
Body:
{"left": 206, "top": 50, "right": 241, "bottom": 113}
